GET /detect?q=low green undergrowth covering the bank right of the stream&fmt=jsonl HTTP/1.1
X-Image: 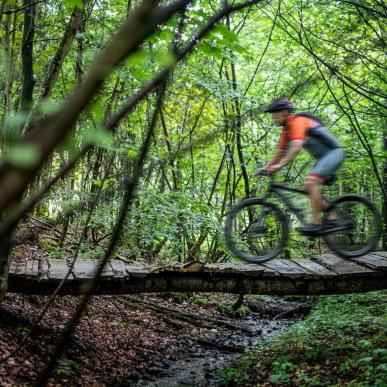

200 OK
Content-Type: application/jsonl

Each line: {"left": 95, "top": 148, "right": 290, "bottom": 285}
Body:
{"left": 221, "top": 291, "right": 387, "bottom": 387}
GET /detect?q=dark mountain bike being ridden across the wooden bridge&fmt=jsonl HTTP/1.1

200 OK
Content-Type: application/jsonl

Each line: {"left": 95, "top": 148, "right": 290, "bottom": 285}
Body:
{"left": 224, "top": 173, "right": 382, "bottom": 263}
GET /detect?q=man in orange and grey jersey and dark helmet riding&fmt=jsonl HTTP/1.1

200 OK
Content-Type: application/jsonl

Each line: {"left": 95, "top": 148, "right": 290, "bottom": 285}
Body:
{"left": 262, "top": 98, "right": 344, "bottom": 234}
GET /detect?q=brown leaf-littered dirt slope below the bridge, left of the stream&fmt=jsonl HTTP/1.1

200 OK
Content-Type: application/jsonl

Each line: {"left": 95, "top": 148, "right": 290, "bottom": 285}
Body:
{"left": 0, "top": 244, "right": 306, "bottom": 386}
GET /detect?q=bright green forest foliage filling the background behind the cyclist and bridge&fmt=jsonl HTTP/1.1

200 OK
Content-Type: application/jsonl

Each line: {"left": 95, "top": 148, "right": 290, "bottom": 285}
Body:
{"left": 0, "top": 0, "right": 387, "bottom": 261}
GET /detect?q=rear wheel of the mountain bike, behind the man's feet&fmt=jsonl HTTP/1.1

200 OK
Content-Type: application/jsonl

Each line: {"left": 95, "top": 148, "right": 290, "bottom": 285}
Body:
{"left": 322, "top": 195, "right": 382, "bottom": 258}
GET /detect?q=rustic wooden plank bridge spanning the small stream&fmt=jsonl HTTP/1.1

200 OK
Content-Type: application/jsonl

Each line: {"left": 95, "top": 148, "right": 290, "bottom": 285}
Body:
{"left": 9, "top": 252, "right": 387, "bottom": 295}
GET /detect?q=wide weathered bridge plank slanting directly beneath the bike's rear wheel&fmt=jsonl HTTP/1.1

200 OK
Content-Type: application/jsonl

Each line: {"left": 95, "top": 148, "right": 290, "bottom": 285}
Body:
{"left": 311, "top": 254, "right": 379, "bottom": 277}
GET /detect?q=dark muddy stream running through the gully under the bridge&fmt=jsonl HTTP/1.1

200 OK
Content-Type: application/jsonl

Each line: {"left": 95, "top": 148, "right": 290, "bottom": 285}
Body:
{"left": 130, "top": 297, "right": 309, "bottom": 387}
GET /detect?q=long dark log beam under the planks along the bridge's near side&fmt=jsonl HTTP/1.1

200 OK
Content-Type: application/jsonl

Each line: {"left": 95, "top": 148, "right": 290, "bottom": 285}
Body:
{"left": 9, "top": 274, "right": 387, "bottom": 295}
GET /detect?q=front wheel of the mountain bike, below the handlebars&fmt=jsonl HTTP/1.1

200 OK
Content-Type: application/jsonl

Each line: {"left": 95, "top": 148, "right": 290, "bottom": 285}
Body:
{"left": 224, "top": 199, "right": 289, "bottom": 263}
